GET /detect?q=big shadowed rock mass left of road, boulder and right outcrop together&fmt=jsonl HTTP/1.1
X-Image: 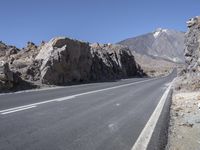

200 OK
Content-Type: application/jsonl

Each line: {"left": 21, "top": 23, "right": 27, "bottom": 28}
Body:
{"left": 35, "top": 37, "right": 142, "bottom": 85}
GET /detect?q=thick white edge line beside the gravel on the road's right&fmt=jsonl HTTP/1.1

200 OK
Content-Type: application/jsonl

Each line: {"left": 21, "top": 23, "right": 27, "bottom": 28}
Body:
{"left": 131, "top": 80, "right": 174, "bottom": 150}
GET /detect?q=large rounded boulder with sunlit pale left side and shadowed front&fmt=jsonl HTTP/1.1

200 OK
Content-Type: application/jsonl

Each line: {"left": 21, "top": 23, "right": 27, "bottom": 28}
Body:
{"left": 36, "top": 37, "right": 92, "bottom": 85}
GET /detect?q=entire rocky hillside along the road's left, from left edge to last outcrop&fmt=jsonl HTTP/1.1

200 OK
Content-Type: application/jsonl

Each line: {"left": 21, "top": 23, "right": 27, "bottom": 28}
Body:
{"left": 0, "top": 37, "right": 144, "bottom": 89}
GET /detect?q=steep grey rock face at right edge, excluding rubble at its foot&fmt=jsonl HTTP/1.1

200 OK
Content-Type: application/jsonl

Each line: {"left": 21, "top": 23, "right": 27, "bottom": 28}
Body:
{"left": 185, "top": 17, "right": 200, "bottom": 75}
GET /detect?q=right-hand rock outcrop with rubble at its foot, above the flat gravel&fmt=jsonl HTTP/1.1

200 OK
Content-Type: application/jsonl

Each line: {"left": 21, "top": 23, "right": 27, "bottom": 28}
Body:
{"left": 176, "top": 16, "right": 200, "bottom": 91}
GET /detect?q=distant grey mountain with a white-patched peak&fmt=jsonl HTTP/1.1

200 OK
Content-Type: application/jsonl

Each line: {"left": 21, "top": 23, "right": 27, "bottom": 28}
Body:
{"left": 119, "top": 28, "right": 184, "bottom": 62}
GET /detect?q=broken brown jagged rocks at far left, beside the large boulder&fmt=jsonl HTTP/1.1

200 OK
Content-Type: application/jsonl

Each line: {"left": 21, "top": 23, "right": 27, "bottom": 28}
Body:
{"left": 0, "top": 42, "right": 38, "bottom": 92}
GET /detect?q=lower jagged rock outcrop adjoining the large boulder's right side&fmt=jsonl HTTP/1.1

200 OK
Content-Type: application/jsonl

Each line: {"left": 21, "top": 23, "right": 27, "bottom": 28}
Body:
{"left": 91, "top": 43, "right": 143, "bottom": 80}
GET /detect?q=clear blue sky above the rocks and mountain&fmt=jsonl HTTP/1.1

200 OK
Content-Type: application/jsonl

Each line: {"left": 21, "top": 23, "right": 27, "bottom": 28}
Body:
{"left": 0, "top": 0, "right": 200, "bottom": 47}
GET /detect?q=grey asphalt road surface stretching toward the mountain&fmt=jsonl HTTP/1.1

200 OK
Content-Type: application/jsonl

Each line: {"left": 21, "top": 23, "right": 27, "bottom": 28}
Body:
{"left": 0, "top": 72, "right": 176, "bottom": 150}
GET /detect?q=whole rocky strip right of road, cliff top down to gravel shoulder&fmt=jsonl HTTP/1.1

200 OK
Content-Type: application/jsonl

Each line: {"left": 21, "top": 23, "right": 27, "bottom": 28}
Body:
{"left": 167, "top": 17, "right": 200, "bottom": 150}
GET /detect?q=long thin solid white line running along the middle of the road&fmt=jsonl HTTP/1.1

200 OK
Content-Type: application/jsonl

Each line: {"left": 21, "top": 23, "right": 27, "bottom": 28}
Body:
{"left": 0, "top": 78, "right": 157, "bottom": 114}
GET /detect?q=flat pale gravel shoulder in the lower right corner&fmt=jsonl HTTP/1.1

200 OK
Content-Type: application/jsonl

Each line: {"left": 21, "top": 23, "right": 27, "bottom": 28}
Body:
{"left": 167, "top": 91, "right": 200, "bottom": 150}
